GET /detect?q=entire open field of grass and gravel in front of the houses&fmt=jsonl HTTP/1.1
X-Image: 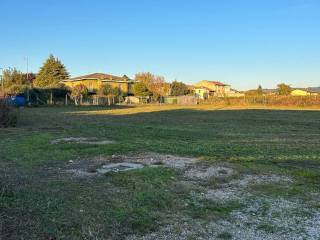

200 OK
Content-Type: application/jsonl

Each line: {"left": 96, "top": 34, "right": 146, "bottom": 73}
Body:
{"left": 0, "top": 106, "right": 320, "bottom": 239}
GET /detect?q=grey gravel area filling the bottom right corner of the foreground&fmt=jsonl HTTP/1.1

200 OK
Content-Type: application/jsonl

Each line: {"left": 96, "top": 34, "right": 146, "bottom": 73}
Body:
{"left": 127, "top": 197, "right": 320, "bottom": 240}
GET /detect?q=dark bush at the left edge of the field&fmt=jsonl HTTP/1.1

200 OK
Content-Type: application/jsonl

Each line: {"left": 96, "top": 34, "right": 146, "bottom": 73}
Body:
{"left": 0, "top": 99, "right": 17, "bottom": 128}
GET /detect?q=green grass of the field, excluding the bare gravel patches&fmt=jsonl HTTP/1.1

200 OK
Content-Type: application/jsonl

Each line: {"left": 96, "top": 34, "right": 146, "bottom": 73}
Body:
{"left": 0, "top": 106, "right": 320, "bottom": 239}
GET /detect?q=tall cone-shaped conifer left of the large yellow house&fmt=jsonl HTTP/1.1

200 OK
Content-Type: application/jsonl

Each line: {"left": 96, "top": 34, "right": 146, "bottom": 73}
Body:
{"left": 33, "top": 55, "right": 69, "bottom": 88}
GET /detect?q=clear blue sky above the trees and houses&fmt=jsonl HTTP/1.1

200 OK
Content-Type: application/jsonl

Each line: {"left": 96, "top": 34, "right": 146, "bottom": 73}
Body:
{"left": 0, "top": 0, "right": 320, "bottom": 89}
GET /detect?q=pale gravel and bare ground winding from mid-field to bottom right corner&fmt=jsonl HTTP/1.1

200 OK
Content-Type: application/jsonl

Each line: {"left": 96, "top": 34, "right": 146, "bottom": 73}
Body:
{"left": 63, "top": 153, "right": 320, "bottom": 240}
